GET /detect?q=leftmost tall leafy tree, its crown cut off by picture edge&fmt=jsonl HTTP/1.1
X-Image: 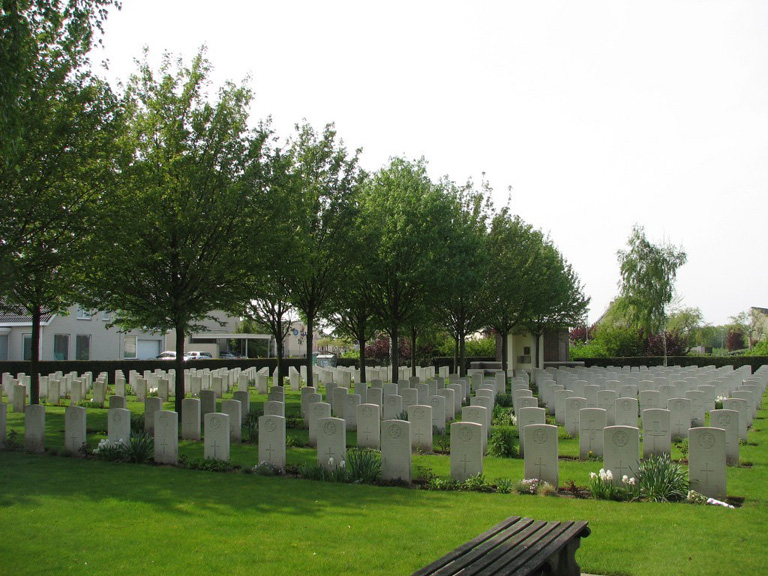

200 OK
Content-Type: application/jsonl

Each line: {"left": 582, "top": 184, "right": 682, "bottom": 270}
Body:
{"left": 0, "top": 0, "right": 120, "bottom": 404}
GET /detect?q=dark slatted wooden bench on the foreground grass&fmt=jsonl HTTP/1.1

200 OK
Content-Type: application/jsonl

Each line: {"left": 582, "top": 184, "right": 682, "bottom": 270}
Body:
{"left": 413, "top": 516, "right": 590, "bottom": 576}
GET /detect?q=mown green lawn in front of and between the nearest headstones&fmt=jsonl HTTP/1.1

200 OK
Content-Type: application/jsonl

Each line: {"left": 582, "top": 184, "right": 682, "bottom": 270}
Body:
{"left": 0, "top": 382, "right": 768, "bottom": 575}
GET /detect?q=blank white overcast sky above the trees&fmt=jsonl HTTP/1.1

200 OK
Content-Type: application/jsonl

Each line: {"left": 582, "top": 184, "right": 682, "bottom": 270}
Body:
{"left": 92, "top": 0, "right": 768, "bottom": 324}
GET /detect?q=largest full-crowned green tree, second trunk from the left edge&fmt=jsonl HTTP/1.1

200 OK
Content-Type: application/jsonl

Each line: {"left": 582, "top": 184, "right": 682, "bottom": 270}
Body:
{"left": 85, "top": 51, "right": 264, "bottom": 415}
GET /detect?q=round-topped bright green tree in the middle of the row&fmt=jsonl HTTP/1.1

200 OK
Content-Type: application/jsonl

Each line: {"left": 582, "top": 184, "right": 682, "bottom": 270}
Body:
{"left": 360, "top": 158, "right": 452, "bottom": 378}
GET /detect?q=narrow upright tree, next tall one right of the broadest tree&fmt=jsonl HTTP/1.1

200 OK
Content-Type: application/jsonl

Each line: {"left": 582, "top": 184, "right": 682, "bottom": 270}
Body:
{"left": 280, "top": 124, "right": 362, "bottom": 386}
